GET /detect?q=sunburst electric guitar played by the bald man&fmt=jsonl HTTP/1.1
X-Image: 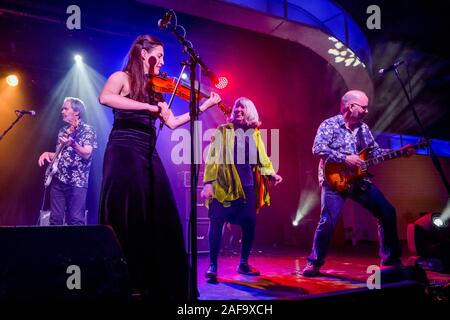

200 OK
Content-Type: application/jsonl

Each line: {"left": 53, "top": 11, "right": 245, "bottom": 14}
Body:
{"left": 323, "top": 141, "right": 429, "bottom": 192}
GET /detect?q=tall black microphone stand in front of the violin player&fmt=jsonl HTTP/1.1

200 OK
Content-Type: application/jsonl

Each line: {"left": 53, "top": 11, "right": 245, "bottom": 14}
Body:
{"left": 166, "top": 16, "right": 210, "bottom": 301}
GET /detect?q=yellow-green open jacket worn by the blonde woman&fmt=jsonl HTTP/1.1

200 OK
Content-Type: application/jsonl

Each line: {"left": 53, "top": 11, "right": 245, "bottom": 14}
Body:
{"left": 203, "top": 123, "right": 275, "bottom": 209}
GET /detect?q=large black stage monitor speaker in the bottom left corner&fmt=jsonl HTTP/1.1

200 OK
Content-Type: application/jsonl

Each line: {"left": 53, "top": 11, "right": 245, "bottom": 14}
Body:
{"left": 0, "top": 225, "right": 128, "bottom": 302}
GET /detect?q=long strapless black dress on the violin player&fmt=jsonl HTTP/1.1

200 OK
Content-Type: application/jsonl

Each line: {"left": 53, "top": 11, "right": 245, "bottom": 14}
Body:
{"left": 100, "top": 97, "right": 189, "bottom": 301}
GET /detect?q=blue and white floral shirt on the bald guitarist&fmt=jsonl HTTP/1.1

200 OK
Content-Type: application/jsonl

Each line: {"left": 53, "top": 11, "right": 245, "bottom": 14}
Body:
{"left": 312, "top": 114, "right": 390, "bottom": 185}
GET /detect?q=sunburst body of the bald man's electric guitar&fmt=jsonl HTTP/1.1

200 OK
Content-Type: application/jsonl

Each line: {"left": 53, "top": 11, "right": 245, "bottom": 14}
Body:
{"left": 323, "top": 149, "right": 368, "bottom": 192}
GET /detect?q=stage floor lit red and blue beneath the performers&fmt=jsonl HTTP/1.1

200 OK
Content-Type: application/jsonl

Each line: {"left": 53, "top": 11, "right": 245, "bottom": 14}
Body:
{"left": 197, "top": 244, "right": 450, "bottom": 300}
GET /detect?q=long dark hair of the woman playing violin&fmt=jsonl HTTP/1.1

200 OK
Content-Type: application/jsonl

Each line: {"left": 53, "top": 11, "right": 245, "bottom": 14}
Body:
{"left": 123, "top": 35, "right": 163, "bottom": 102}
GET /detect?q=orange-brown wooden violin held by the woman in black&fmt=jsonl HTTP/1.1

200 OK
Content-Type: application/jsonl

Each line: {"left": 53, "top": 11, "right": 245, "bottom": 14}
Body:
{"left": 148, "top": 73, "right": 232, "bottom": 117}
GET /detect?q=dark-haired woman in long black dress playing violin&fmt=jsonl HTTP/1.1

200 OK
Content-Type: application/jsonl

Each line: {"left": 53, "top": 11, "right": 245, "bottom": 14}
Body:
{"left": 99, "top": 35, "right": 220, "bottom": 301}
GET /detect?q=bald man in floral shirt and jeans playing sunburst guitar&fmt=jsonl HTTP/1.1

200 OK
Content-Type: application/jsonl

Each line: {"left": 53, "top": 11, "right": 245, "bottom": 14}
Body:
{"left": 303, "top": 90, "right": 415, "bottom": 277}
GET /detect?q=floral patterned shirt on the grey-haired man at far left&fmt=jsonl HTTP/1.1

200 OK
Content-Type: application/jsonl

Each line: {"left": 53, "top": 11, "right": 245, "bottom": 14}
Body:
{"left": 55, "top": 121, "right": 97, "bottom": 188}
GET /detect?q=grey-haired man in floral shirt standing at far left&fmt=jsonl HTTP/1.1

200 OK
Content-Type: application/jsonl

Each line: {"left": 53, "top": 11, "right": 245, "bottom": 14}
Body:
{"left": 38, "top": 97, "right": 97, "bottom": 225}
